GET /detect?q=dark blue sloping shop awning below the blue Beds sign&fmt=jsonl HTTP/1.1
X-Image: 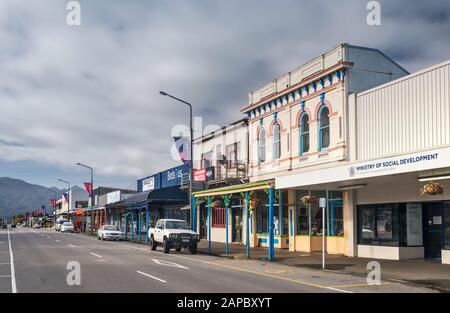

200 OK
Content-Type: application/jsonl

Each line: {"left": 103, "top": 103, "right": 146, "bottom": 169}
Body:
{"left": 125, "top": 187, "right": 189, "bottom": 206}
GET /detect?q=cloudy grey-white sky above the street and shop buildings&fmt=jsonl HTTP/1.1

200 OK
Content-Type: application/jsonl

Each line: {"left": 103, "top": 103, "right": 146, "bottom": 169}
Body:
{"left": 0, "top": 0, "right": 450, "bottom": 188}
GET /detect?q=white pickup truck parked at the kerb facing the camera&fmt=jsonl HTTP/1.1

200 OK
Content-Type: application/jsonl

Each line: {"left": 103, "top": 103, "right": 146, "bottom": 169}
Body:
{"left": 148, "top": 219, "right": 199, "bottom": 254}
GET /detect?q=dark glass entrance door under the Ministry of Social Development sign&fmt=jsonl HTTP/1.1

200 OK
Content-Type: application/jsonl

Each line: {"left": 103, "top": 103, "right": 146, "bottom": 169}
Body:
{"left": 423, "top": 203, "right": 443, "bottom": 259}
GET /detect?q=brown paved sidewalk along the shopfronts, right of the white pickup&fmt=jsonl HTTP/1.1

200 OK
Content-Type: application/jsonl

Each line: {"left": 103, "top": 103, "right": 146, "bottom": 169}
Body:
{"left": 198, "top": 240, "right": 450, "bottom": 292}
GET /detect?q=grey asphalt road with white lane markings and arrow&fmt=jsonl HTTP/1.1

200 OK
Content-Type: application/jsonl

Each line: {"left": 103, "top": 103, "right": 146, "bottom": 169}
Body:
{"left": 0, "top": 228, "right": 432, "bottom": 293}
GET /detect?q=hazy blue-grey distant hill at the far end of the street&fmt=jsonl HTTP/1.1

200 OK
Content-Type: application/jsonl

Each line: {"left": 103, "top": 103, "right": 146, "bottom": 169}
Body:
{"left": 0, "top": 177, "right": 63, "bottom": 217}
